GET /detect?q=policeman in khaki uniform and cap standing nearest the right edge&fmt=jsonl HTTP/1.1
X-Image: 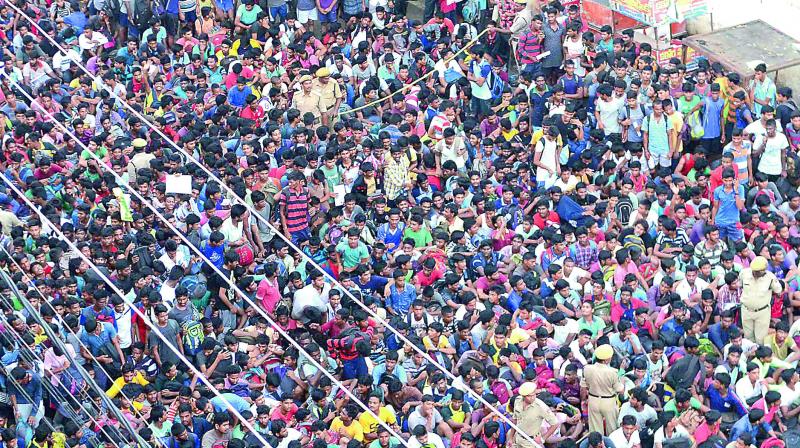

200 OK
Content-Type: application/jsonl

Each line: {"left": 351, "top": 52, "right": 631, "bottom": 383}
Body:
{"left": 739, "top": 256, "right": 783, "bottom": 343}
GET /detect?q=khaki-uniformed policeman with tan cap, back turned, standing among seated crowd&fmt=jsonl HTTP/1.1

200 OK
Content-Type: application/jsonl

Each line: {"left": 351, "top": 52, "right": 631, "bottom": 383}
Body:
{"left": 581, "top": 344, "right": 625, "bottom": 435}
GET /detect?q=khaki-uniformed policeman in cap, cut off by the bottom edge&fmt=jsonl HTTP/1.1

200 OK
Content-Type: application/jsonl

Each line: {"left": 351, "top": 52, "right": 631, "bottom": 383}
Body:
{"left": 506, "top": 381, "right": 560, "bottom": 448}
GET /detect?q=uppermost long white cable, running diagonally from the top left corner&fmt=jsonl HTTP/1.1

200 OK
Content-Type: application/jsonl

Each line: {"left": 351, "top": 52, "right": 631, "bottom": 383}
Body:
{"left": 1, "top": 7, "right": 540, "bottom": 447}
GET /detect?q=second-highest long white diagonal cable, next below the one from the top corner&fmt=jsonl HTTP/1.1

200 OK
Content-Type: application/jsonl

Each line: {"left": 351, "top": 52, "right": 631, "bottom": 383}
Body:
{"left": 1, "top": 80, "right": 408, "bottom": 446}
